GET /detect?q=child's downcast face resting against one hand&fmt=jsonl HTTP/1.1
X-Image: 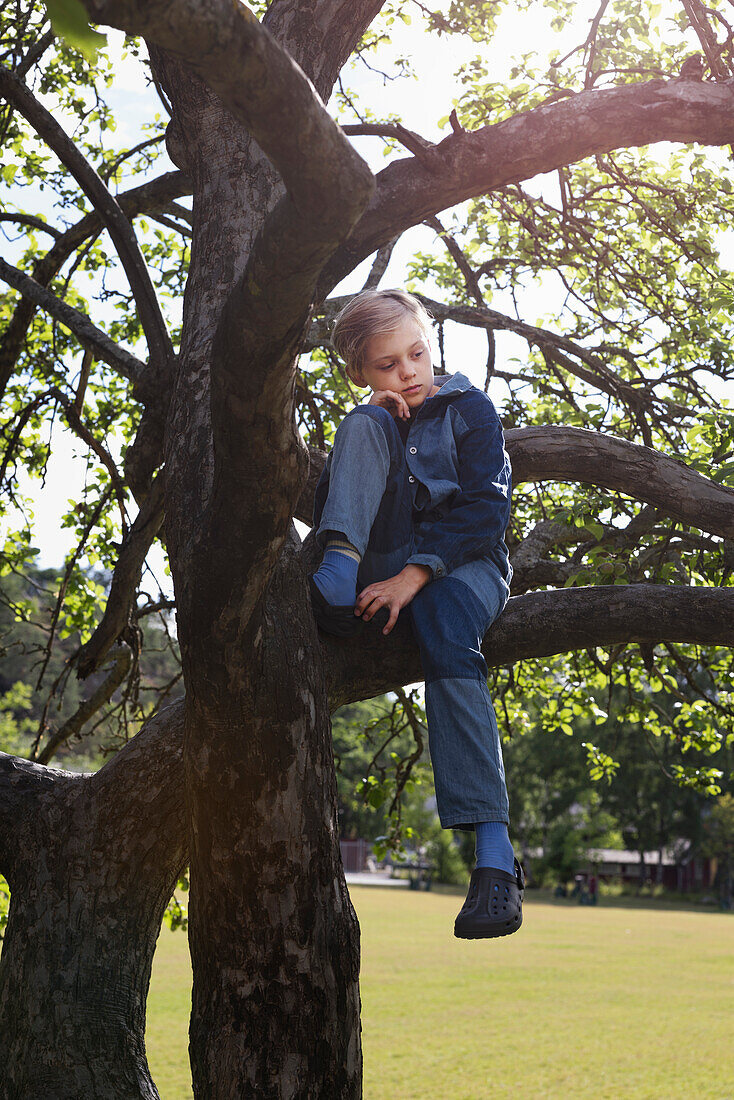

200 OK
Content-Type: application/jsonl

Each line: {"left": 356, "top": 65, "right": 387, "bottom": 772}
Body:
{"left": 357, "top": 314, "right": 438, "bottom": 410}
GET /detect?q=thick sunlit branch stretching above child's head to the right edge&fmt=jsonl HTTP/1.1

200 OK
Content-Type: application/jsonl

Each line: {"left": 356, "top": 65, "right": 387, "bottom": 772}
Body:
{"left": 320, "top": 80, "right": 734, "bottom": 299}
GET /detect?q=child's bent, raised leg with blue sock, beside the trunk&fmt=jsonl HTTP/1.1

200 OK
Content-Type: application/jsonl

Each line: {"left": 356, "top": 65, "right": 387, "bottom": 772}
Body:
{"left": 314, "top": 406, "right": 412, "bottom": 629}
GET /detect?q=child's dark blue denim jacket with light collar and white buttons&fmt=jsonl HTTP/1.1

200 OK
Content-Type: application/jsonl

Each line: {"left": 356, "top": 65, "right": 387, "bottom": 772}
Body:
{"left": 405, "top": 374, "right": 512, "bottom": 583}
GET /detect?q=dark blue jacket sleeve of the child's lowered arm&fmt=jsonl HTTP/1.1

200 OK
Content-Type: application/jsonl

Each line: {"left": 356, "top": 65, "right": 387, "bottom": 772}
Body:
{"left": 408, "top": 395, "right": 512, "bottom": 578}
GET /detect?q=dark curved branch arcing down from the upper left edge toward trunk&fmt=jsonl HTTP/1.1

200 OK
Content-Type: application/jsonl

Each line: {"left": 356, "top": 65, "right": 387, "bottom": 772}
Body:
{"left": 0, "top": 66, "right": 175, "bottom": 376}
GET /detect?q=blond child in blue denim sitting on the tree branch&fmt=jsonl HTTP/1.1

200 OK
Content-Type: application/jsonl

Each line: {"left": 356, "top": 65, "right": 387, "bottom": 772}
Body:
{"left": 311, "top": 290, "right": 524, "bottom": 939}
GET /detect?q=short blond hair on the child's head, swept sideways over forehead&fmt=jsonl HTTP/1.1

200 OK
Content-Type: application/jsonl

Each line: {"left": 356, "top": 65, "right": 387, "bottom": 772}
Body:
{"left": 331, "top": 290, "right": 432, "bottom": 385}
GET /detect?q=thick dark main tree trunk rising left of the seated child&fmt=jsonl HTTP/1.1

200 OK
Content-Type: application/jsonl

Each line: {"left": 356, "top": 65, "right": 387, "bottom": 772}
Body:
{"left": 149, "top": 10, "right": 380, "bottom": 1100}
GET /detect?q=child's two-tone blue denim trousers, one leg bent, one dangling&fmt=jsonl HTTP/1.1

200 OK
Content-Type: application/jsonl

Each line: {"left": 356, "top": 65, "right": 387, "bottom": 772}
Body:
{"left": 314, "top": 405, "right": 510, "bottom": 829}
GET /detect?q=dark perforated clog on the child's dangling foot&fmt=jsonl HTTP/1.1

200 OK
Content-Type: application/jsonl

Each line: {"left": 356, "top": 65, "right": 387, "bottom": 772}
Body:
{"left": 453, "top": 860, "right": 525, "bottom": 939}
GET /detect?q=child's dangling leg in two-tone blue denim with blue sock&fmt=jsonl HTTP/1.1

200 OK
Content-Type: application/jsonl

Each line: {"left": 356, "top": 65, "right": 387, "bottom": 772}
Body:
{"left": 410, "top": 562, "right": 514, "bottom": 873}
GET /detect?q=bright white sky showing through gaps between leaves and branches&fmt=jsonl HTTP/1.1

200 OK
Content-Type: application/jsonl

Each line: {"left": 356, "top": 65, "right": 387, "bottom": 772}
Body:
{"left": 0, "top": 2, "right": 713, "bottom": 595}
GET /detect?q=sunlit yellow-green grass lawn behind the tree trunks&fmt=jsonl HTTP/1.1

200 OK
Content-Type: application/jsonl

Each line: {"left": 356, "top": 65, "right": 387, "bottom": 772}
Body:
{"left": 147, "top": 887, "right": 734, "bottom": 1100}
